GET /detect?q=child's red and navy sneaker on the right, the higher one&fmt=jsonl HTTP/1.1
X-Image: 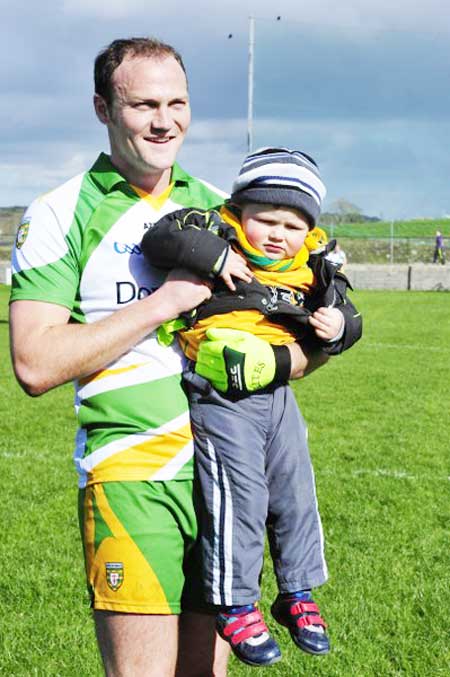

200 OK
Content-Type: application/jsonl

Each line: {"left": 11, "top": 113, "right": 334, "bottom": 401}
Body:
{"left": 271, "top": 592, "right": 330, "bottom": 656}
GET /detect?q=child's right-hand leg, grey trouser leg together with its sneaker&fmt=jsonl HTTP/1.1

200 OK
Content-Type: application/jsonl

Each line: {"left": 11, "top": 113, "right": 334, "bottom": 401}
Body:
{"left": 267, "top": 387, "right": 330, "bottom": 655}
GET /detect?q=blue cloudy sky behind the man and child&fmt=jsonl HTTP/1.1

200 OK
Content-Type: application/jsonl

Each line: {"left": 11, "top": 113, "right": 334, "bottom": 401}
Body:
{"left": 0, "top": 0, "right": 450, "bottom": 219}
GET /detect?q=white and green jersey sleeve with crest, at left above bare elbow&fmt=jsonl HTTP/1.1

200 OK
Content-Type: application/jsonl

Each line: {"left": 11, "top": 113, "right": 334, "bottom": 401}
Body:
{"left": 10, "top": 198, "right": 79, "bottom": 309}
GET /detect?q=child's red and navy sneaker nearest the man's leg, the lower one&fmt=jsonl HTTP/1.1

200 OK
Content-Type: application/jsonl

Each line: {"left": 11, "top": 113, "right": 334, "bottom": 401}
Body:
{"left": 216, "top": 604, "right": 281, "bottom": 667}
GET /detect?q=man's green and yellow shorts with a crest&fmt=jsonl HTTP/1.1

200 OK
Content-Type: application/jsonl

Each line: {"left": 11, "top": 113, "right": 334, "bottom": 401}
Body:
{"left": 79, "top": 480, "right": 201, "bottom": 614}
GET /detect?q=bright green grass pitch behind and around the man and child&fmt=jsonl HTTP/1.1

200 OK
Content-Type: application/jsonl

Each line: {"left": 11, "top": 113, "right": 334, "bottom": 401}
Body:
{"left": 0, "top": 287, "right": 450, "bottom": 677}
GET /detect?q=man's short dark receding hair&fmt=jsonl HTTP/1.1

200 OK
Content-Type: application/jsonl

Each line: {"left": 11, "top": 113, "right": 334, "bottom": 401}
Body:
{"left": 94, "top": 38, "right": 186, "bottom": 106}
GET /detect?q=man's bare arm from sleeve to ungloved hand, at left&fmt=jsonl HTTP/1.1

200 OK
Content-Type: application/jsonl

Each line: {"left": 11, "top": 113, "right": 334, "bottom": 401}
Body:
{"left": 10, "top": 271, "right": 211, "bottom": 396}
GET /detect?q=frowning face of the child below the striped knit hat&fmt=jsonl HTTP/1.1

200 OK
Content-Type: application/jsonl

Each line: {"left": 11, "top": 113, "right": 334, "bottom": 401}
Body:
{"left": 241, "top": 202, "right": 309, "bottom": 261}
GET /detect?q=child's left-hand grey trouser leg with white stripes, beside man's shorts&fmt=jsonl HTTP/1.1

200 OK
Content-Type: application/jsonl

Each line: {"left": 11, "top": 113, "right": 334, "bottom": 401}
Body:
{"left": 185, "top": 374, "right": 268, "bottom": 607}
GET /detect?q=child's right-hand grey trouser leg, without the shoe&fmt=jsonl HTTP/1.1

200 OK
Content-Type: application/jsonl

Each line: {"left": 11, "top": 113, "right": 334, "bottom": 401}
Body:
{"left": 266, "top": 386, "right": 328, "bottom": 593}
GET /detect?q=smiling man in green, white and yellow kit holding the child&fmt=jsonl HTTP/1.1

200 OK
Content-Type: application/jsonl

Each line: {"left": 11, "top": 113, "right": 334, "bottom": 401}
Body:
{"left": 10, "top": 38, "right": 326, "bottom": 677}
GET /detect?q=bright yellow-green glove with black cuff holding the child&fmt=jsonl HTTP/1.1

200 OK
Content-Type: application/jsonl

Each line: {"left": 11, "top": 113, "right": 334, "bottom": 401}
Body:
{"left": 195, "top": 329, "right": 291, "bottom": 395}
